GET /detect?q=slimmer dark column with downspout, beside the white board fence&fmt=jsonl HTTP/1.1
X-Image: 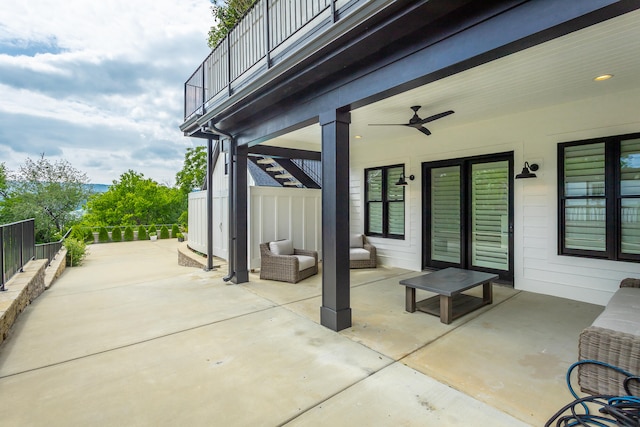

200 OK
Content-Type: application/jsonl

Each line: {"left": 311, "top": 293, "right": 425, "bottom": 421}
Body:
{"left": 229, "top": 141, "right": 249, "bottom": 284}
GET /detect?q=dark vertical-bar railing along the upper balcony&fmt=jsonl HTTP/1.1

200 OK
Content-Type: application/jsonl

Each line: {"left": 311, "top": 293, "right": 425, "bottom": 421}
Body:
{"left": 184, "top": 0, "right": 376, "bottom": 121}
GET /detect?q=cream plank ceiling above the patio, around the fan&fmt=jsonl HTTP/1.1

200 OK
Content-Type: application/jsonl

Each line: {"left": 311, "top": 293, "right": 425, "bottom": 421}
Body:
{"left": 266, "top": 11, "right": 640, "bottom": 149}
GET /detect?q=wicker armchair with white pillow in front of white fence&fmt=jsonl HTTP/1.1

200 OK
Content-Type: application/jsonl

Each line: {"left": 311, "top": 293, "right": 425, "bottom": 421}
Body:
{"left": 260, "top": 242, "right": 318, "bottom": 283}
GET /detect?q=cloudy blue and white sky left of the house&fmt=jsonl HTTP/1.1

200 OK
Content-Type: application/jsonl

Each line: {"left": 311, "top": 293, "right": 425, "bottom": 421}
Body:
{"left": 0, "top": 0, "right": 213, "bottom": 185}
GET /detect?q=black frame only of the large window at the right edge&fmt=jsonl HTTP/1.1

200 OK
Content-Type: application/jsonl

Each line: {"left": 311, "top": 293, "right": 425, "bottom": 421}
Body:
{"left": 557, "top": 133, "right": 640, "bottom": 262}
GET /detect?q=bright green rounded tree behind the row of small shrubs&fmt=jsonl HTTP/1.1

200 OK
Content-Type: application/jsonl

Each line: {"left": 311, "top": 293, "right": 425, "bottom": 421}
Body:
{"left": 84, "top": 170, "right": 187, "bottom": 226}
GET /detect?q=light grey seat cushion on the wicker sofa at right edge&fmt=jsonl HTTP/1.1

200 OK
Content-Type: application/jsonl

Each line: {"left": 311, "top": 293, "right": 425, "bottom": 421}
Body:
{"left": 593, "top": 288, "right": 640, "bottom": 335}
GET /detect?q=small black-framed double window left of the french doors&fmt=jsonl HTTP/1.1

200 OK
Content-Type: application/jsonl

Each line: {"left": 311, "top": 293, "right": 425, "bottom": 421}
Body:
{"left": 364, "top": 165, "right": 404, "bottom": 239}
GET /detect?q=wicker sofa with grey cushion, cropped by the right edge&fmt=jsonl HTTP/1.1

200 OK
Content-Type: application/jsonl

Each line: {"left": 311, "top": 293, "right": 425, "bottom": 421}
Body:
{"left": 578, "top": 279, "right": 640, "bottom": 396}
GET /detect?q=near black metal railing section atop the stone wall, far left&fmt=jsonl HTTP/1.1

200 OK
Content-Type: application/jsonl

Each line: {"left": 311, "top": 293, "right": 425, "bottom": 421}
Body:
{"left": 0, "top": 218, "right": 36, "bottom": 291}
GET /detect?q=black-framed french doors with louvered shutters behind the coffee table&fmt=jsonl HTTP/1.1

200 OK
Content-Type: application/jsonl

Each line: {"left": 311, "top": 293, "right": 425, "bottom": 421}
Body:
{"left": 422, "top": 153, "right": 513, "bottom": 282}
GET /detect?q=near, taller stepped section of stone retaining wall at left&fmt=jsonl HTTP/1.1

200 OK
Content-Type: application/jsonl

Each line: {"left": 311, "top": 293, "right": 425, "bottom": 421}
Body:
{"left": 0, "top": 259, "right": 47, "bottom": 343}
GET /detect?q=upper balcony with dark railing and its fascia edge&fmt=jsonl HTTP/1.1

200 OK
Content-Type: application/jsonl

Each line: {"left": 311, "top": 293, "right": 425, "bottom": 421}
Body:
{"left": 180, "top": 0, "right": 406, "bottom": 136}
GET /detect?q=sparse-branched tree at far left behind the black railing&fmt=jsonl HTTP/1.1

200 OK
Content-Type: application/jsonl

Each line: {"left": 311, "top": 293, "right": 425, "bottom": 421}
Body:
{"left": 0, "top": 154, "right": 91, "bottom": 242}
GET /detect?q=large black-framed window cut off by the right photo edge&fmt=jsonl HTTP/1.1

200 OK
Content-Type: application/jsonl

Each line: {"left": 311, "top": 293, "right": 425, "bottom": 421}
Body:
{"left": 558, "top": 134, "right": 640, "bottom": 261}
